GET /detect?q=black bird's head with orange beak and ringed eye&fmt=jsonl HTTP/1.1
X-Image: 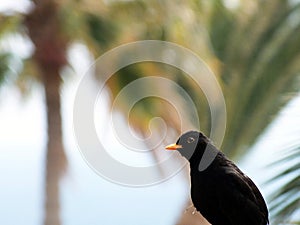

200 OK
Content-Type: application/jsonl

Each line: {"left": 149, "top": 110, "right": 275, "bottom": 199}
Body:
{"left": 166, "top": 131, "right": 210, "bottom": 160}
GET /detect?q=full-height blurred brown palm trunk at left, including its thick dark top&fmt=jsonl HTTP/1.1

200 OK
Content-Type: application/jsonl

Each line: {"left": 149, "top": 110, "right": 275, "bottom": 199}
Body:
{"left": 24, "top": 0, "right": 67, "bottom": 225}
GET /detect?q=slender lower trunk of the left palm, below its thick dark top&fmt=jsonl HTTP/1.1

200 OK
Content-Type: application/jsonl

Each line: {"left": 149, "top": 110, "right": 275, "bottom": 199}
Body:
{"left": 44, "top": 71, "right": 66, "bottom": 225}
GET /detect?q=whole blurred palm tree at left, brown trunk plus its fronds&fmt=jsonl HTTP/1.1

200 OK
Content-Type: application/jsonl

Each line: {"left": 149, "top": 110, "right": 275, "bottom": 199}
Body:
{"left": 0, "top": 0, "right": 119, "bottom": 225}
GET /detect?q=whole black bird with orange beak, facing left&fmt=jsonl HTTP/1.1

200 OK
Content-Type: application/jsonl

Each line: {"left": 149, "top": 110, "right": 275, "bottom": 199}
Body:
{"left": 166, "top": 131, "right": 269, "bottom": 225}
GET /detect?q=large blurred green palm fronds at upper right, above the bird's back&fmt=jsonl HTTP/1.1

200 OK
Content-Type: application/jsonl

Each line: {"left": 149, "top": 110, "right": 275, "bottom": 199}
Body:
{"left": 210, "top": 0, "right": 300, "bottom": 157}
